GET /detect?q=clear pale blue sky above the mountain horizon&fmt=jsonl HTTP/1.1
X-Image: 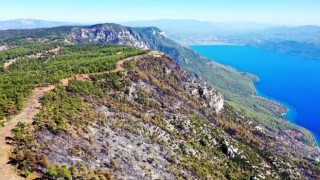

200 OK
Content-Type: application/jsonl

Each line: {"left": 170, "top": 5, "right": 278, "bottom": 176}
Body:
{"left": 0, "top": 0, "right": 320, "bottom": 25}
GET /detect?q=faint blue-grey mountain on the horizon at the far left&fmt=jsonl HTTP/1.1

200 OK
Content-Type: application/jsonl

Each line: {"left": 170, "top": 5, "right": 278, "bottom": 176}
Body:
{"left": 0, "top": 19, "right": 81, "bottom": 30}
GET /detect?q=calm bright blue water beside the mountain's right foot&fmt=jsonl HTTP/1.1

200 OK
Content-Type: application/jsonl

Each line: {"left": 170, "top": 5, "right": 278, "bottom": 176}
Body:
{"left": 191, "top": 46, "right": 320, "bottom": 145}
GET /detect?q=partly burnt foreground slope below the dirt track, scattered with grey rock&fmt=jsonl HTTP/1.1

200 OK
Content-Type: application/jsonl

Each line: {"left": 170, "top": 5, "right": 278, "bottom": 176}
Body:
{"left": 8, "top": 48, "right": 315, "bottom": 179}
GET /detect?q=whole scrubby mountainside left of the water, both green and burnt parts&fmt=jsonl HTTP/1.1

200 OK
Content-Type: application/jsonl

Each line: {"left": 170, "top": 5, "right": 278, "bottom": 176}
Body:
{"left": 0, "top": 24, "right": 320, "bottom": 179}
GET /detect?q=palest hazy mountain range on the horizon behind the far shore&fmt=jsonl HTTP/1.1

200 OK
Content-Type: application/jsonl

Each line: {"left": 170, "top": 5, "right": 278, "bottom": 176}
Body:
{"left": 122, "top": 20, "right": 320, "bottom": 41}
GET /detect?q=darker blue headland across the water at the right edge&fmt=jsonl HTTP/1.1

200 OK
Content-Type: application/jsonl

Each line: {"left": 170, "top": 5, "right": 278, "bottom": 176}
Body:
{"left": 236, "top": 26, "right": 320, "bottom": 60}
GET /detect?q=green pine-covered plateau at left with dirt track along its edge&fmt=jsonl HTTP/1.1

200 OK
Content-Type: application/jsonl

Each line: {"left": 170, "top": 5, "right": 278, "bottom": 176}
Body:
{"left": 0, "top": 41, "right": 150, "bottom": 179}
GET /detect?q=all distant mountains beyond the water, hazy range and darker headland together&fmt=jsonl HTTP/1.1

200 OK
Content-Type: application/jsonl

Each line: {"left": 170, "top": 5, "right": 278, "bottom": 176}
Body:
{"left": 123, "top": 20, "right": 320, "bottom": 60}
